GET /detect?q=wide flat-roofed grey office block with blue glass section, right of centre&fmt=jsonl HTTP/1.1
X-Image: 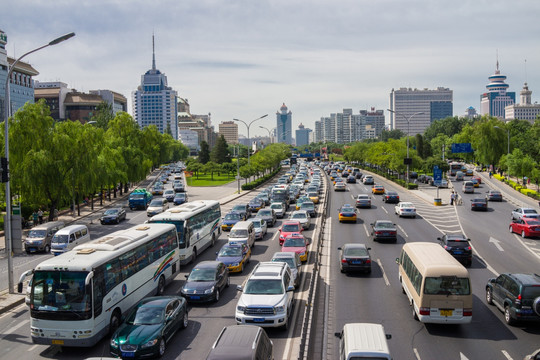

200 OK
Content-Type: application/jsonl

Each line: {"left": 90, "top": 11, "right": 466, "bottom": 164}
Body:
{"left": 390, "top": 87, "right": 453, "bottom": 135}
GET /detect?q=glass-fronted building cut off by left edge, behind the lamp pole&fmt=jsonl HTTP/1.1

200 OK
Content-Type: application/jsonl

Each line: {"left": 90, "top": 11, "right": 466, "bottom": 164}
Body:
{"left": 0, "top": 30, "right": 39, "bottom": 121}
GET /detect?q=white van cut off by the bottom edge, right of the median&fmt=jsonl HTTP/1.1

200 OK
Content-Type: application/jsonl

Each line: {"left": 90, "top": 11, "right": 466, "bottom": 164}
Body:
{"left": 335, "top": 323, "right": 392, "bottom": 360}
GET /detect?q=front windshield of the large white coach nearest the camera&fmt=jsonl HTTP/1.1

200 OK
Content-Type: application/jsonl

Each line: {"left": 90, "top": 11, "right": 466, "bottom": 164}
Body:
{"left": 30, "top": 271, "right": 92, "bottom": 320}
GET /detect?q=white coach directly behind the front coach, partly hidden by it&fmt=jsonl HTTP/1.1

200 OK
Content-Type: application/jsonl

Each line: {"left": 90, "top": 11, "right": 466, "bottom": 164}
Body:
{"left": 148, "top": 200, "right": 221, "bottom": 265}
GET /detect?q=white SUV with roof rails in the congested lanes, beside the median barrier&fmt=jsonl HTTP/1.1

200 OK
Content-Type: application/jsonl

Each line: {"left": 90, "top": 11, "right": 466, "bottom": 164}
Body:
{"left": 235, "top": 262, "right": 294, "bottom": 330}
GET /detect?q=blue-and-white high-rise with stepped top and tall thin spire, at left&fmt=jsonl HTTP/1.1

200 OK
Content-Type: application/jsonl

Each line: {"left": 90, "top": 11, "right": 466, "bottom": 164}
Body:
{"left": 132, "top": 36, "right": 178, "bottom": 140}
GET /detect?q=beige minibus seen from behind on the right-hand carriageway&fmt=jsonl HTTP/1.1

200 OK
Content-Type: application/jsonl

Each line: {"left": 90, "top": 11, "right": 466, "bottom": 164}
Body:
{"left": 396, "top": 242, "right": 473, "bottom": 324}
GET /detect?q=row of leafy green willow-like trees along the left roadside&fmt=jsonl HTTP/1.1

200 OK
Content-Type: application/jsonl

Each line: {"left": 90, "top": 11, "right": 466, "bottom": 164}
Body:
{"left": 0, "top": 100, "right": 189, "bottom": 221}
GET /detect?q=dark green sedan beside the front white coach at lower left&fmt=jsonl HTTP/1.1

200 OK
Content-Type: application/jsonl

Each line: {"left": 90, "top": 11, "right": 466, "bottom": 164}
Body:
{"left": 109, "top": 295, "right": 189, "bottom": 359}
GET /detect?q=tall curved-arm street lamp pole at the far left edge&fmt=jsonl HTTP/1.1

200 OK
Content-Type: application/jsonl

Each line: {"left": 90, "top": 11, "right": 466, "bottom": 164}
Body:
{"left": 4, "top": 33, "right": 75, "bottom": 294}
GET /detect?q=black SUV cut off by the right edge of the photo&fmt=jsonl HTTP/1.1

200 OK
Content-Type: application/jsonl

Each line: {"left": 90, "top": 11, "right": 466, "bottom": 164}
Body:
{"left": 486, "top": 274, "right": 540, "bottom": 325}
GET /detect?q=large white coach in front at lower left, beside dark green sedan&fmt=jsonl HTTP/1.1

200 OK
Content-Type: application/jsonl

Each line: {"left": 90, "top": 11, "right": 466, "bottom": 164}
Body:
{"left": 18, "top": 224, "right": 180, "bottom": 347}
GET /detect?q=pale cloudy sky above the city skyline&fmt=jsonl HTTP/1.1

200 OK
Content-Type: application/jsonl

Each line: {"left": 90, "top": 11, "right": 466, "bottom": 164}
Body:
{"left": 0, "top": 0, "right": 540, "bottom": 137}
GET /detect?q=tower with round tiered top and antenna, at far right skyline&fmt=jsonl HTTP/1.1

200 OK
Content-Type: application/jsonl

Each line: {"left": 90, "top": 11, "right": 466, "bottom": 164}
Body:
{"left": 480, "top": 60, "right": 516, "bottom": 120}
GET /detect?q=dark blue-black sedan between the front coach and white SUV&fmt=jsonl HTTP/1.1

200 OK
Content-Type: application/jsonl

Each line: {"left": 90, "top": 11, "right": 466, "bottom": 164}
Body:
{"left": 180, "top": 261, "right": 230, "bottom": 302}
